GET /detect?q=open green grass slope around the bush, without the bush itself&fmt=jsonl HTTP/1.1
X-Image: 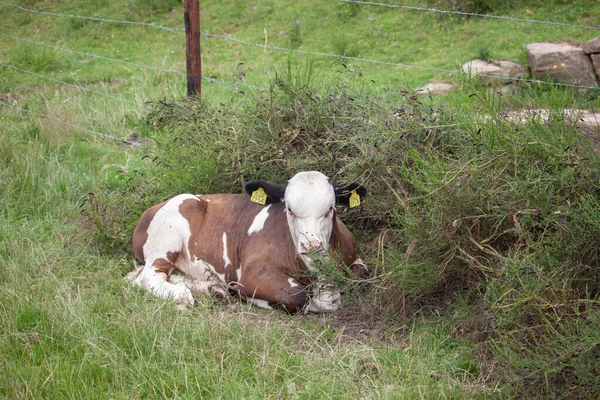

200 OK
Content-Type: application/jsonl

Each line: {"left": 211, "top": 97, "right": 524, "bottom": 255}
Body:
{"left": 0, "top": 1, "right": 600, "bottom": 398}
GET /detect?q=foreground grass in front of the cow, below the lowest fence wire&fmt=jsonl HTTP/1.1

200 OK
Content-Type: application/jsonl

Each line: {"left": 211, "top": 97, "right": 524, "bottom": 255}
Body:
{"left": 0, "top": 101, "right": 487, "bottom": 398}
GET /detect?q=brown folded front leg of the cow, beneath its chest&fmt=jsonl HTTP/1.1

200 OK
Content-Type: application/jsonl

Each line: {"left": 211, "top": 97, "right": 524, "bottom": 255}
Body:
{"left": 235, "top": 266, "right": 309, "bottom": 314}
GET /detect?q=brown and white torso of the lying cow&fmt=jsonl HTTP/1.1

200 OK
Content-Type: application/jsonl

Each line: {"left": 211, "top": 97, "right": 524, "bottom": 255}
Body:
{"left": 133, "top": 194, "right": 303, "bottom": 281}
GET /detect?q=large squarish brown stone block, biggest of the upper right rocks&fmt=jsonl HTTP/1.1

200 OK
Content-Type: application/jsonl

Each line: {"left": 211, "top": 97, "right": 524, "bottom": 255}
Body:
{"left": 527, "top": 43, "right": 598, "bottom": 86}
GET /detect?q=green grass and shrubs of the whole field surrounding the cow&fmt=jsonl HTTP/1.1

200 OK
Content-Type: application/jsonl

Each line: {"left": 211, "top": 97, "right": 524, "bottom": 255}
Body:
{"left": 0, "top": 0, "right": 600, "bottom": 399}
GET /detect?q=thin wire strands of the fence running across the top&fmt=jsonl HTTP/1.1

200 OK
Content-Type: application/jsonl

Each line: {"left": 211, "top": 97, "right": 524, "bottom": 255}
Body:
{"left": 0, "top": 0, "right": 600, "bottom": 144}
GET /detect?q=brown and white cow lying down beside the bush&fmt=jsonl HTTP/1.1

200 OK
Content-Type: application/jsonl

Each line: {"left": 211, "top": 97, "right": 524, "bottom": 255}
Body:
{"left": 132, "top": 171, "right": 368, "bottom": 313}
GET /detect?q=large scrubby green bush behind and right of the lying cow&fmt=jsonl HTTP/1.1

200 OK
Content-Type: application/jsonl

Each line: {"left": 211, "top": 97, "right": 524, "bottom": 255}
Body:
{"left": 89, "top": 60, "right": 600, "bottom": 396}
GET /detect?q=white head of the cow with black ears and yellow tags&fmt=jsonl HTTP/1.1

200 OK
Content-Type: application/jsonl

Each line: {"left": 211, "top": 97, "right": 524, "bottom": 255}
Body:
{"left": 246, "top": 171, "right": 366, "bottom": 262}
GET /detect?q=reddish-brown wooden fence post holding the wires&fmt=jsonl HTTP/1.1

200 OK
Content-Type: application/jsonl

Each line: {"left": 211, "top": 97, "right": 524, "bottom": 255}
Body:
{"left": 183, "top": 0, "right": 202, "bottom": 97}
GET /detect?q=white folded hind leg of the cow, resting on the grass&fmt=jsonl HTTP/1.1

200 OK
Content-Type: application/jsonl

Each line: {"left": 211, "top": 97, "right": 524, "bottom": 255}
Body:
{"left": 133, "top": 258, "right": 194, "bottom": 304}
